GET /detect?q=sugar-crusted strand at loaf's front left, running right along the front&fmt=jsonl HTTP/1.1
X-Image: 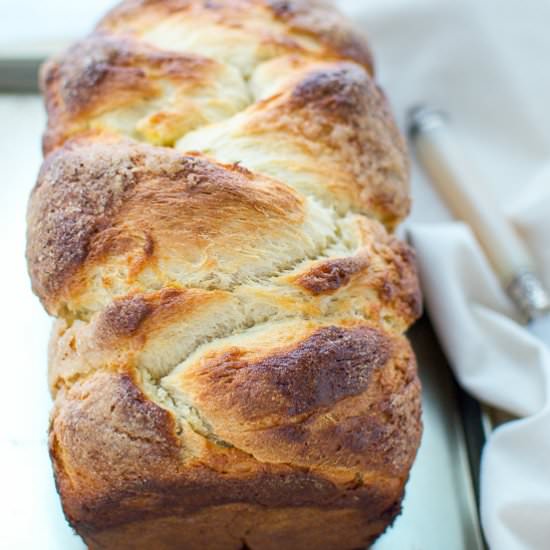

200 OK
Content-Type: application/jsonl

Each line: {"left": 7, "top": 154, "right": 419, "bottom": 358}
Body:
{"left": 50, "top": 364, "right": 416, "bottom": 535}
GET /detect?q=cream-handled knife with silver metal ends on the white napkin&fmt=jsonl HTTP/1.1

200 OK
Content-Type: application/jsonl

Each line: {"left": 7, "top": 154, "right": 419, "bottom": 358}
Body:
{"left": 408, "top": 106, "right": 550, "bottom": 346}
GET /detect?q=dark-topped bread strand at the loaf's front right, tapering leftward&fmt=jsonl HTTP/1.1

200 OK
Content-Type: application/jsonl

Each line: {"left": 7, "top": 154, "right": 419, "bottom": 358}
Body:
{"left": 163, "top": 324, "right": 420, "bottom": 479}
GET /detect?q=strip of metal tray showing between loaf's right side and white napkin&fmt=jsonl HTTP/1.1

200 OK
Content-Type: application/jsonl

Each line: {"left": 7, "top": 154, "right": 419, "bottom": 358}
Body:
{"left": 374, "top": 315, "right": 487, "bottom": 550}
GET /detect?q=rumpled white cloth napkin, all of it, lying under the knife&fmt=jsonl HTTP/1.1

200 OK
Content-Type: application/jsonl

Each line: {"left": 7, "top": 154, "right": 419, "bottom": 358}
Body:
{"left": 334, "top": 0, "right": 550, "bottom": 550}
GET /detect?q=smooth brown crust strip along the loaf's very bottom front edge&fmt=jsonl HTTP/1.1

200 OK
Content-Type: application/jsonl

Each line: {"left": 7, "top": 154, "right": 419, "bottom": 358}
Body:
{"left": 87, "top": 504, "right": 395, "bottom": 550}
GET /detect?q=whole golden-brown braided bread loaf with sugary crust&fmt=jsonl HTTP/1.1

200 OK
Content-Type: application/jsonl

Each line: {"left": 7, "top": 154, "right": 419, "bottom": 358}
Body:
{"left": 27, "top": 0, "right": 421, "bottom": 550}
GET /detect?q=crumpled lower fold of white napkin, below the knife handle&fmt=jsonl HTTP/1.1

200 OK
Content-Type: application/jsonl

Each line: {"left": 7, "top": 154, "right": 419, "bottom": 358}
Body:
{"left": 411, "top": 216, "right": 550, "bottom": 550}
